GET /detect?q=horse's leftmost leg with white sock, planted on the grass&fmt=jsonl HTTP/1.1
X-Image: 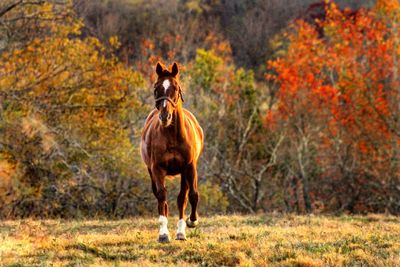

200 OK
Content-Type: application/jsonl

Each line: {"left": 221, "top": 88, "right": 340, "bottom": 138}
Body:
{"left": 149, "top": 169, "right": 170, "bottom": 243}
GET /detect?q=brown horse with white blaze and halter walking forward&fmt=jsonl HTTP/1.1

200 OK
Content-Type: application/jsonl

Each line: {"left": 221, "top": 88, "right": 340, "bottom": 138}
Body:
{"left": 141, "top": 63, "right": 204, "bottom": 242}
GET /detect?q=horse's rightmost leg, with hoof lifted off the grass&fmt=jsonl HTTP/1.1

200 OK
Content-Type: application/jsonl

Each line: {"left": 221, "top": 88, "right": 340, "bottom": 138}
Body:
{"left": 185, "top": 163, "right": 199, "bottom": 228}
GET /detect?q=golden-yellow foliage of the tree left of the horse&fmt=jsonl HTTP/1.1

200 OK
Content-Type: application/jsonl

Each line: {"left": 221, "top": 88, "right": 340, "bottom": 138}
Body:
{"left": 0, "top": 1, "right": 147, "bottom": 222}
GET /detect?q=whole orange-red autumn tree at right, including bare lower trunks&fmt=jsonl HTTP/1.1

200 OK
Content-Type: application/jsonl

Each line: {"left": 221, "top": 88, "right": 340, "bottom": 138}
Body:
{"left": 267, "top": 0, "right": 400, "bottom": 212}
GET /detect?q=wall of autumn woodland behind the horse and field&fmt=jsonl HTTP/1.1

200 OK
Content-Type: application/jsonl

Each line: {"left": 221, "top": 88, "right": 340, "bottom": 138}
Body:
{"left": 0, "top": 0, "right": 400, "bottom": 218}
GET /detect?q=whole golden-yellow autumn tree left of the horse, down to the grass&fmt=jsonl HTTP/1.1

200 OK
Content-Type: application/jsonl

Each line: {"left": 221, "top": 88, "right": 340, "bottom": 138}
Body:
{"left": 0, "top": 1, "right": 152, "bottom": 216}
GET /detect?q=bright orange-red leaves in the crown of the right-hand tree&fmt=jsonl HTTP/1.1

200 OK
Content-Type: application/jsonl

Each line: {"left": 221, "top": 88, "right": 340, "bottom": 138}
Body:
{"left": 266, "top": 0, "right": 400, "bottom": 157}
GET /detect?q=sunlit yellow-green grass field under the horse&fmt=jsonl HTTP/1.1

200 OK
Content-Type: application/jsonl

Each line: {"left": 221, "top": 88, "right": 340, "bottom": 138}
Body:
{"left": 0, "top": 215, "right": 400, "bottom": 266}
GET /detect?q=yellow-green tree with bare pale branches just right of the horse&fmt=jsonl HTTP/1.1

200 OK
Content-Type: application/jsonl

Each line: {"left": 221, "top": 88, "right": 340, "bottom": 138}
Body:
{"left": 177, "top": 47, "right": 280, "bottom": 215}
